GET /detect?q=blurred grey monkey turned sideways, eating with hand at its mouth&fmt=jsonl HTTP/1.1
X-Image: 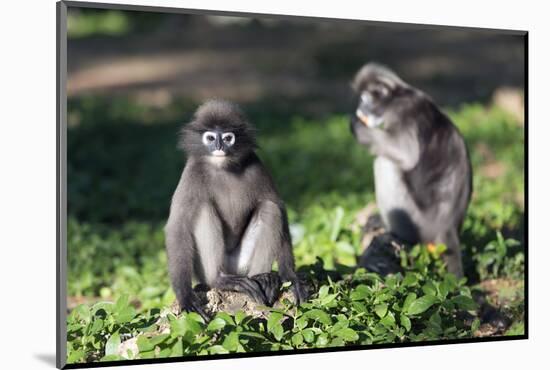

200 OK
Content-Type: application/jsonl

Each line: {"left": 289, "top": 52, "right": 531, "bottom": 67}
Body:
{"left": 351, "top": 63, "right": 472, "bottom": 277}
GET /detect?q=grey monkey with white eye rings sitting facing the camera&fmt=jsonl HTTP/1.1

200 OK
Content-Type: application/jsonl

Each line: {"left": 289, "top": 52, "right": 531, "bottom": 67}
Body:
{"left": 165, "top": 100, "right": 306, "bottom": 317}
